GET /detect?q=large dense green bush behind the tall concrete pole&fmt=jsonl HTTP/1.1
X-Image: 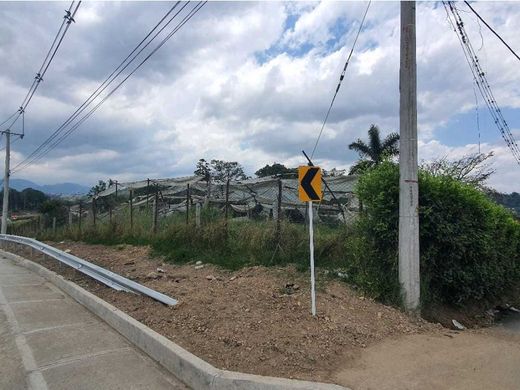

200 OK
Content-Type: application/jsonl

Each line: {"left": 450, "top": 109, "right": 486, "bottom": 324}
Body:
{"left": 349, "top": 162, "right": 520, "bottom": 305}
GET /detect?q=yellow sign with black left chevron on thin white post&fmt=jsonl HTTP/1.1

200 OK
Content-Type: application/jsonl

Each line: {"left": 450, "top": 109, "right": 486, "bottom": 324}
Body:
{"left": 298, "top": 166, "right": 323, "bottom": 316}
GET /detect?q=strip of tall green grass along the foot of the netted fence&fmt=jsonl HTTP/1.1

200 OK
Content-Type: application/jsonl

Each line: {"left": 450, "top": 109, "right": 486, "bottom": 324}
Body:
{"left": 29, "top": 209, "right": 349, "bottom": 270}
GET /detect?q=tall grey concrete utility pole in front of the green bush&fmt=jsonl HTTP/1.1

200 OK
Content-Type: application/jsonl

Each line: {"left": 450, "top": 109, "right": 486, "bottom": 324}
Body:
{"left": 399, "top": 1, "right": 420, "bottom": 312}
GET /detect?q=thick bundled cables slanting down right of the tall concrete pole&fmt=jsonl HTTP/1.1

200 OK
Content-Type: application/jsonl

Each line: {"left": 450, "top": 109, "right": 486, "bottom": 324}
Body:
{"left": 443, "top": 1, "right": 520, "bottom": 165}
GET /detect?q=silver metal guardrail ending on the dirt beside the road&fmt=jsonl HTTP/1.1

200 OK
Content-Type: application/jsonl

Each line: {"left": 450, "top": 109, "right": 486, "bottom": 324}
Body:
{"left": 0, "top": 234, "right": 177, "bottom": 306}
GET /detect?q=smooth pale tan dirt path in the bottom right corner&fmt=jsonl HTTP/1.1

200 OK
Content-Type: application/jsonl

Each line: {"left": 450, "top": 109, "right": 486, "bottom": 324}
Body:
{"left": 334, "top": 328, "right": 520, "bottom": 390}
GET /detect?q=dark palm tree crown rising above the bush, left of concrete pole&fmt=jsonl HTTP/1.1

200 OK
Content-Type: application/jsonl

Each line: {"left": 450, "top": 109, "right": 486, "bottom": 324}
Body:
{"left": 348, "top": 125, "right": 399, "bottom": 175}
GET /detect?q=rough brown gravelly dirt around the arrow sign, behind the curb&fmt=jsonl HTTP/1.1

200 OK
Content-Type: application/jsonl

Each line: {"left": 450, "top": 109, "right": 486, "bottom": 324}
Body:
{"left": 12, "top": 242, "right": 436, "bottom": 383}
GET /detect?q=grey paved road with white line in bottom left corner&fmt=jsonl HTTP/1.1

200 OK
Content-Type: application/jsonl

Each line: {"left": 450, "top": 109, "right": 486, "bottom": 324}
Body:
{"left": 0, "top": 257, "right": 186, "bottom": 390}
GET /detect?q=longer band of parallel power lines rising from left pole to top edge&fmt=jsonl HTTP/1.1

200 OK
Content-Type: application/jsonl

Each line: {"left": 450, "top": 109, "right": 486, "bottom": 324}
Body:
{"left": 14, "top": 1, "right": 207, "bottom": 172}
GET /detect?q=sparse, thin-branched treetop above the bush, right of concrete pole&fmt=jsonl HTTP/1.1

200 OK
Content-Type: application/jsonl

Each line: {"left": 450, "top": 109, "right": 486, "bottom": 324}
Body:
{"left": 421, "top": 152, "right": 495, "bottom": 188}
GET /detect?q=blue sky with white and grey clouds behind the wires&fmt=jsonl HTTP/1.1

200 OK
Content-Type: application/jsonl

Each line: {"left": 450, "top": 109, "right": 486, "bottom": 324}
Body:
{"left": 0, "top": 2, "right": 520, "bottom": 192}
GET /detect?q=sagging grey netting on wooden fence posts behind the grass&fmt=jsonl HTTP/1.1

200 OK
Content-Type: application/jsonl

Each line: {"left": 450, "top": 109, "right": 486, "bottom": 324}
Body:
{"left": 69, "top": 176, "right": 359, "bottom": 232}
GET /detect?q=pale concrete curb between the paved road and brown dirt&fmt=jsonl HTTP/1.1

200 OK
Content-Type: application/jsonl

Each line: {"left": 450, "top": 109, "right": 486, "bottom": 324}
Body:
{"left": 0, "top": 251, "right": 348, "bottom": 390}
